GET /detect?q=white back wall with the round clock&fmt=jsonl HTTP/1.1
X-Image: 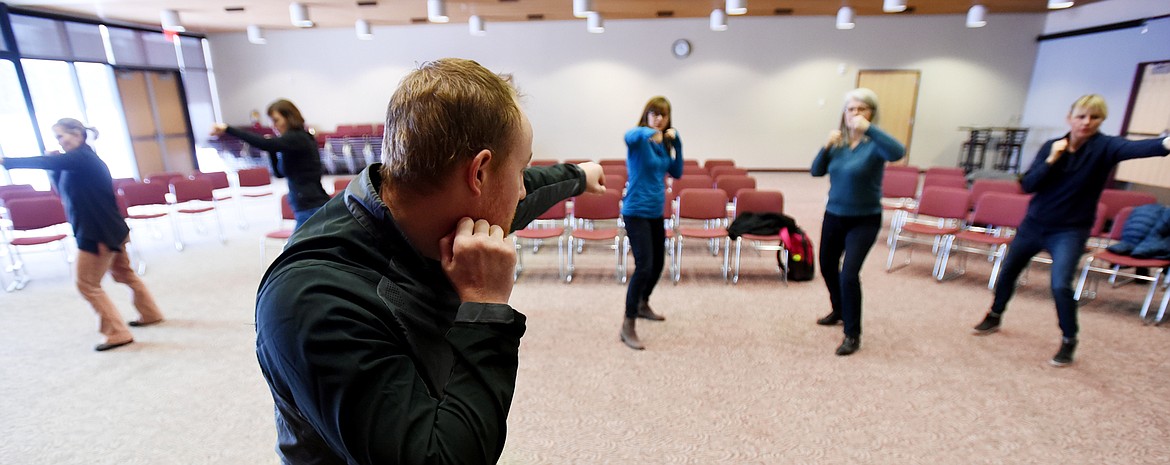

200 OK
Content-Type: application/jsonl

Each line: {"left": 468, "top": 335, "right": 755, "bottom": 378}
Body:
{"left": 209, "top": 13, "right": 1045, "bottom": 169}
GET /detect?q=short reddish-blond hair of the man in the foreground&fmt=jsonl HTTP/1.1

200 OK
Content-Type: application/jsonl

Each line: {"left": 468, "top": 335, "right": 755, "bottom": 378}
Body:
{"left": 381, "top": 59, "right": 528, "bottom": 193}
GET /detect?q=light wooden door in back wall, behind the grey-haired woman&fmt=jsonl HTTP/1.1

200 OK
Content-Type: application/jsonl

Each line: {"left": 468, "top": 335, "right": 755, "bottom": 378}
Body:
{"left": 858, "top": 69, "right": 922, "bottom": 165}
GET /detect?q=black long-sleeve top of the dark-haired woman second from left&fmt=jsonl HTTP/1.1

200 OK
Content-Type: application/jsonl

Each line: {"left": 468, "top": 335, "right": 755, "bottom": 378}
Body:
{"left": 227, "top": 126, "right": 329, "bottom": 211}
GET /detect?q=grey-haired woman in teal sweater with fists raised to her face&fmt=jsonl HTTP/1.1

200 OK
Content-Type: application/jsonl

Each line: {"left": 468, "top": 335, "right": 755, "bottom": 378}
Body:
{"left": 810, "top": 88, "right": 906, "bottom": 355}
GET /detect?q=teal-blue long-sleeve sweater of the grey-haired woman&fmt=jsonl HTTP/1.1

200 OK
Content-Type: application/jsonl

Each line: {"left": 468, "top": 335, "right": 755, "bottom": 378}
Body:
{"left": 810, "top": 124, "right": 906, "bottom": 217}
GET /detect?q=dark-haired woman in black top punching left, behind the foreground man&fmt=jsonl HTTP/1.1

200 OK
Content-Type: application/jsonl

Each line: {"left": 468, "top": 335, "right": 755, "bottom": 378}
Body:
{"left": 212, "top": 98, "right": 329, "bottom": 228}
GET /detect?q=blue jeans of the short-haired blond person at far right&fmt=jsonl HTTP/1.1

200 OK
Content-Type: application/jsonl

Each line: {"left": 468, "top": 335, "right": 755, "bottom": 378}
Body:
{"left": 991, "top": 221, "right": 1089, "bottom": 339}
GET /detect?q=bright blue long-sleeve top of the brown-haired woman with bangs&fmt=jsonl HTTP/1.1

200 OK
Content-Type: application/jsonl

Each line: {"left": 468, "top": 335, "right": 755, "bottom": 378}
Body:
{"left": 621, "top": 126, "right": 682, "bottom": 218}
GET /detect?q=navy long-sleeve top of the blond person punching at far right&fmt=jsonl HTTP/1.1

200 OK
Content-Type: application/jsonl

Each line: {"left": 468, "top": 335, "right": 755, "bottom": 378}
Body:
{"left": 1020, "top": 134, "right": 1170, "bottom": 230}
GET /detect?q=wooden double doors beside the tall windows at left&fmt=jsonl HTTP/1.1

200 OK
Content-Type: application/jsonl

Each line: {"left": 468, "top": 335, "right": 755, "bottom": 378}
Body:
{"left": 115, "top": 69, "right": 195, "bottom": 178}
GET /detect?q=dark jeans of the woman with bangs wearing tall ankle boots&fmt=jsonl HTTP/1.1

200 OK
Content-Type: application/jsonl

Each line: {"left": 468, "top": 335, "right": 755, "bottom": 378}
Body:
{"left": 621, "top": 217, "right": 666, "bottom": 319}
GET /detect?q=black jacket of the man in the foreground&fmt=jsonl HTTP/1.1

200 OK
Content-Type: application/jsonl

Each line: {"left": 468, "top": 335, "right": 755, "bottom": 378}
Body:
{"left": 256, "top": 164, "right": 585, "bottom": 464}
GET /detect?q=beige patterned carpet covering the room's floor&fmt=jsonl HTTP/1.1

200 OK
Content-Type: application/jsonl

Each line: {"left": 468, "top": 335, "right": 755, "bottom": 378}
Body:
{"left": 0, "top": 173, "right": 1170, "bottom": 464}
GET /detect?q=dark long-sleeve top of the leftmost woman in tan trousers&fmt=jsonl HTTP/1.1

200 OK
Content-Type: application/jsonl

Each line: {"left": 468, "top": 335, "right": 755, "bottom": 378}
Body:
{"left": 4, "top": 144, "right": 130, "bottom": 253}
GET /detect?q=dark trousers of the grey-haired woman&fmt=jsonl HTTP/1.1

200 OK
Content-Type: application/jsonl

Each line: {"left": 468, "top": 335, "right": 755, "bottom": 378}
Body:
{"left": 820, "top": 212, "right": 881, "bottom": 337}
